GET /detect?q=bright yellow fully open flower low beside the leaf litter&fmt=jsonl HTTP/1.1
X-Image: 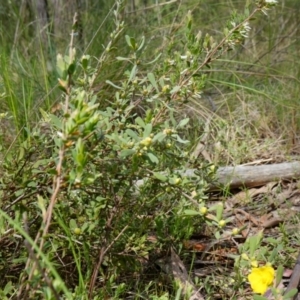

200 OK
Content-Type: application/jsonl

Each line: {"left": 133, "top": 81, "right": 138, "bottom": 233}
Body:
{"left": 248, "top": 266, "right": 275, "bottom": 295}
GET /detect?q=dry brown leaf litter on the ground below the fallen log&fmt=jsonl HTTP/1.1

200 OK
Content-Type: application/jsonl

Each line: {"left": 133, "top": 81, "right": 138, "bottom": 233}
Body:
{"left": 175, "top": 180, "right": 300, "bottom": 300}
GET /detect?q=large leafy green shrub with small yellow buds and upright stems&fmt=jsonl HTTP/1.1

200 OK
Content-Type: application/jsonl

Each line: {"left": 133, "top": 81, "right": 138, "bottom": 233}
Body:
{"left": 0, "top": 1, "right": 296, "bottom": 300}
